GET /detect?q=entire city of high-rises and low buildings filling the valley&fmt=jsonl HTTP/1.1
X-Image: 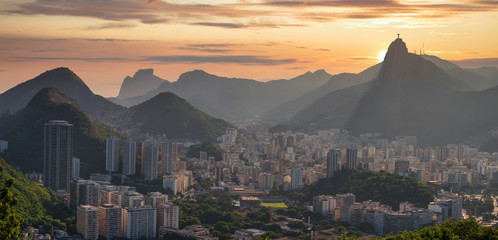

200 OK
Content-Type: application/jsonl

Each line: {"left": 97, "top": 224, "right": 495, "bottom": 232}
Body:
{"left": 0, "top": 114, "right": 498, "bottom": 239}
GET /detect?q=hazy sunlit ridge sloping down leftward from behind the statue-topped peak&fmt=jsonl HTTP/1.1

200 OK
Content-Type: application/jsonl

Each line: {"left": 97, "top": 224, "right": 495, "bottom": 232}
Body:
{"left": 263, "top": 63, "right": 382, "bottom": 121}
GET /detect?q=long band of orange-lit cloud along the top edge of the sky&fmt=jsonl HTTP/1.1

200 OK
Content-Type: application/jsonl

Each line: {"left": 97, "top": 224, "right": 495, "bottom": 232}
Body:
{"left": 0, "top": 0, "right": 498, "bottom": 30}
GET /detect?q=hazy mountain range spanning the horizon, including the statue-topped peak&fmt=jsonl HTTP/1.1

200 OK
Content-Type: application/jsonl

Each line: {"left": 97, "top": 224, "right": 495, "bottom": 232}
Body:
{"left": 0, "top": 39, "right": 498, "bottom": 153}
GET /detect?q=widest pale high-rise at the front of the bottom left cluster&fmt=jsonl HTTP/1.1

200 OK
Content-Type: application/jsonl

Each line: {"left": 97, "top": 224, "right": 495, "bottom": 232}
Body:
{"left": 121, "top": 206, "right": 157, "bottom": 239}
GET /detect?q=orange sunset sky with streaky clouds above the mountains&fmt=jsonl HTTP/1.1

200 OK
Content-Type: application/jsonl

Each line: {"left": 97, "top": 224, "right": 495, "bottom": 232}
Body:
{"left": 0, "top": 0, "right": 498, "bottom": 97}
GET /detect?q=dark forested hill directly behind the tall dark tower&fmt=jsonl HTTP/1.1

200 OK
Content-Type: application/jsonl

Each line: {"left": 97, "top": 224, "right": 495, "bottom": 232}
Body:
{"left": 0, "top": 88, "right": 121, "bottom": 177}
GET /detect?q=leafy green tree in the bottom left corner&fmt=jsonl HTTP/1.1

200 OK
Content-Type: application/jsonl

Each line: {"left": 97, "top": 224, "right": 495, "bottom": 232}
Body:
{"left": 0, "top": 178, "right": 23, "bottom": 240}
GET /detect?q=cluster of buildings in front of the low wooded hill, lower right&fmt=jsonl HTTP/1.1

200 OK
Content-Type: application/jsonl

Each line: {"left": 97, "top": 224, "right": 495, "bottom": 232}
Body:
{"left": 310, "top": 192, "right": 462, "bottom": 236}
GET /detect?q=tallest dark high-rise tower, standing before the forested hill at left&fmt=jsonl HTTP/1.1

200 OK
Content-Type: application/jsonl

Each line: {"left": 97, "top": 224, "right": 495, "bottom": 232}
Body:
{"left": 43, "top": 120, "right": 73, "bottom": 192}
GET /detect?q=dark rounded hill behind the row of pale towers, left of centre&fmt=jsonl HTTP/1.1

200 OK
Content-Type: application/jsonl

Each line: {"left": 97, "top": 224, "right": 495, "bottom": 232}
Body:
{"left": 127, "top": 92, "right": 232, "bottom": 142}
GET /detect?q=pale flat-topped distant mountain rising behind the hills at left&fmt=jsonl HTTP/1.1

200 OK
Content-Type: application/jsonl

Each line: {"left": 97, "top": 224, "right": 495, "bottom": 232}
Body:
{"left": 117, "top": 69, "right": 169, "bottom": 99}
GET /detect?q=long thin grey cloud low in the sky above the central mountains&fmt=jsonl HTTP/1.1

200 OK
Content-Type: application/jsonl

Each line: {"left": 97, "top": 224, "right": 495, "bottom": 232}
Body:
{"left": 144, "top": 55, "right": 298, "bottom": 66}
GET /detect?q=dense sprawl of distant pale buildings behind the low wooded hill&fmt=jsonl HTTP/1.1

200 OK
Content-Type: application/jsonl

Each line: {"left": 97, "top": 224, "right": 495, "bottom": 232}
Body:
{"left": 187, "top": 125, "right": 498, "bottom": 197}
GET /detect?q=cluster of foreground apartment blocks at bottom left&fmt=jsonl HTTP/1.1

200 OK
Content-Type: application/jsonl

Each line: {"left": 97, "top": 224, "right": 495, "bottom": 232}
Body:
{"left": 75, "top": 188, "right": 180, "bottom": 239}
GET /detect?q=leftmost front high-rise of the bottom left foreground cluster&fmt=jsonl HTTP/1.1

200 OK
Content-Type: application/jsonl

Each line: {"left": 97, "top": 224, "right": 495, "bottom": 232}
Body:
{"left": 76, "top": 205, "right": 99, "bottom": 240}
